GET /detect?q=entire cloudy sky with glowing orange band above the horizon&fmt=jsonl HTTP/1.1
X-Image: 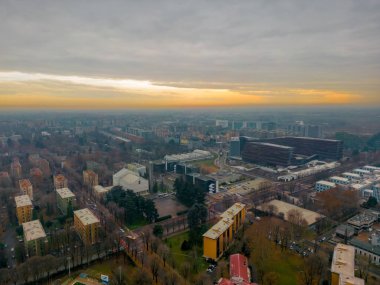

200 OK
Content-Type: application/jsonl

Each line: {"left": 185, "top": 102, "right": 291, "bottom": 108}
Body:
{"left": 0, "top": 0, "right": 380, "bottom": 109}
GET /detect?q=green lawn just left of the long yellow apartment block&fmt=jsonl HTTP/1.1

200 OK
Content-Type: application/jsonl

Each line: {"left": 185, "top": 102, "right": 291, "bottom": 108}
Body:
{"left": 165, "top": 232, "right": 208, "bottom": 272}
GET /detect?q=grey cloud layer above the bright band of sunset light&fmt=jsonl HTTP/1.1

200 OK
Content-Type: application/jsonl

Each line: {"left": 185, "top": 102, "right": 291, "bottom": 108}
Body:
{"left": 0, "top": 0, "right": 380, "bottom": 91}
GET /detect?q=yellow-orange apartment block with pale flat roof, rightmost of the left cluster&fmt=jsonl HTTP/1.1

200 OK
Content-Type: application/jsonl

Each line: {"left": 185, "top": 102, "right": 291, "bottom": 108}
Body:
{"left": 74, "top": 208, "right": 100, "bottom": 245}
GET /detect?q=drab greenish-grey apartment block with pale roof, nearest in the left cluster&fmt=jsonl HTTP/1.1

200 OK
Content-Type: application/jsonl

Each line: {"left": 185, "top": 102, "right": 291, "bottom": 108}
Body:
{"left": 22, "top": 220, "right": 48, "bottom": 256}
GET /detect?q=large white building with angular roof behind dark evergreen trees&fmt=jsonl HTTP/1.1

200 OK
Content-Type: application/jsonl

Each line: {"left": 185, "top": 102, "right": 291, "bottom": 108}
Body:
{"left": 112, "top": 168, "right": 149, "bottom": 196}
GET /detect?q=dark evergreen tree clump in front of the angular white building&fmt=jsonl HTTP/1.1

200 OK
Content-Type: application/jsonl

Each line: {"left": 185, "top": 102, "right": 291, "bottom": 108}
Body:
{"left": 106, "top": 186, "right": 158, "bottom": 225}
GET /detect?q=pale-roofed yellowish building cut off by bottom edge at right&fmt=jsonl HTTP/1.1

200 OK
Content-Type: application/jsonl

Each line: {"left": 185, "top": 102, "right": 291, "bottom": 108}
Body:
{"left": 331, "top": 243, "right": 365, "bottom": 285}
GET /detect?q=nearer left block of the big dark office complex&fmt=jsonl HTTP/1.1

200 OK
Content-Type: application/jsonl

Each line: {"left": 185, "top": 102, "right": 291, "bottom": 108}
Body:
{"left": 241, "top": 142, "right": 294, "bottom": 166}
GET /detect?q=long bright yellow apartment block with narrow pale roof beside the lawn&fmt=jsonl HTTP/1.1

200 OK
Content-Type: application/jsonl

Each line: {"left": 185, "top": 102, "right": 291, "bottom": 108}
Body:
{"left": 203, "top": 203, "right": 246, "bottom": 260}
